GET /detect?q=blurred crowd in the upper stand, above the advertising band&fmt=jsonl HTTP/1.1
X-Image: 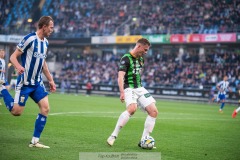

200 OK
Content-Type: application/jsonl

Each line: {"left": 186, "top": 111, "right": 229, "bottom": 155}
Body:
{"left": 0, "top": 0, "right": 240, "bottom": 38}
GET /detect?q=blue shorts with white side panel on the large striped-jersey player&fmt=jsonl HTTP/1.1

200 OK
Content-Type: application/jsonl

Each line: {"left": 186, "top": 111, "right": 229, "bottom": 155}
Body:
{"left": 14, "top": 83, "right": 48, "bottom": 106}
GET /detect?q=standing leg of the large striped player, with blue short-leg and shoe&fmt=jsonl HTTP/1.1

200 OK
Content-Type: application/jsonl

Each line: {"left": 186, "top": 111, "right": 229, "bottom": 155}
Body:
{"left": 29, "top": 85, "right": 50, "bottom": 148}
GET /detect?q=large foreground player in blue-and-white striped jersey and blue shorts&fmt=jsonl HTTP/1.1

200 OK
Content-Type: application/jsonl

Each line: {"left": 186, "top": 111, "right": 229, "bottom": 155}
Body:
{"left": 0, "top": 16, "right": 56, "bottom": 148}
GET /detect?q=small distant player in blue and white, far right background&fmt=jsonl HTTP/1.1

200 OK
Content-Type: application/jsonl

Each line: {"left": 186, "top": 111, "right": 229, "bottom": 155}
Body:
{"left": 216, "top": 76, "right": 232, "bottom": 113}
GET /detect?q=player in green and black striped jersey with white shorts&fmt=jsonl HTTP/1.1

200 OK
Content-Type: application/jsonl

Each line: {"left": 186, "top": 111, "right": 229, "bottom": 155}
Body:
{"left": 107, "top": 38, "right": 158, "bottom": 147}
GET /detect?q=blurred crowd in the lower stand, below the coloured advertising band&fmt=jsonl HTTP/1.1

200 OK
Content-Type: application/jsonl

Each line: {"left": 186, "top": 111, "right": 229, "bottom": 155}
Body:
{"left": 58, "top": 49, "right": 240, "bottom": 91}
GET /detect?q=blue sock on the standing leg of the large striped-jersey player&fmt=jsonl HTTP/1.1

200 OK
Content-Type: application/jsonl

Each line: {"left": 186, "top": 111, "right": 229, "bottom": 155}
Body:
{"left": 33, "top": 113, "right": 47, "bottom": 138}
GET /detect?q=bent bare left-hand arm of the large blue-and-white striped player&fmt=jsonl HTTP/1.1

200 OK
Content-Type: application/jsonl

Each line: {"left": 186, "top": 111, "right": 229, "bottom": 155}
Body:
{"left": 10, "top": 48, "right": 25, "bottom": 74}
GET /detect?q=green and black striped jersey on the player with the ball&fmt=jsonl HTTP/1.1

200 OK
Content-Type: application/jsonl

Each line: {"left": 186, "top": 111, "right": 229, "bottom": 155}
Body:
{"left": 118, "top": 53, "right": 144, "bottom": 89}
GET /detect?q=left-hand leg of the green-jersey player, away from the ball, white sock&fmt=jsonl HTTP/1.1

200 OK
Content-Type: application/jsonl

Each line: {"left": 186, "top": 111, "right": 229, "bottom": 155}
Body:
{"left": 107, "top": 88, "right": 137, "bottom": 146}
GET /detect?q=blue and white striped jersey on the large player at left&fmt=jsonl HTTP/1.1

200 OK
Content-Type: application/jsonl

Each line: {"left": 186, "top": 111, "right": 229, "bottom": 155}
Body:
{"left": 17, "top": 32, "right": 48, "bottom": 85}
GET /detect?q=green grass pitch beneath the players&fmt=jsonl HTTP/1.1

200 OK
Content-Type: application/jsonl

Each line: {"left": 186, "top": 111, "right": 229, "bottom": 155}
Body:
{"left": 0, "top": 94, "right": 240, "bottom": 160}
